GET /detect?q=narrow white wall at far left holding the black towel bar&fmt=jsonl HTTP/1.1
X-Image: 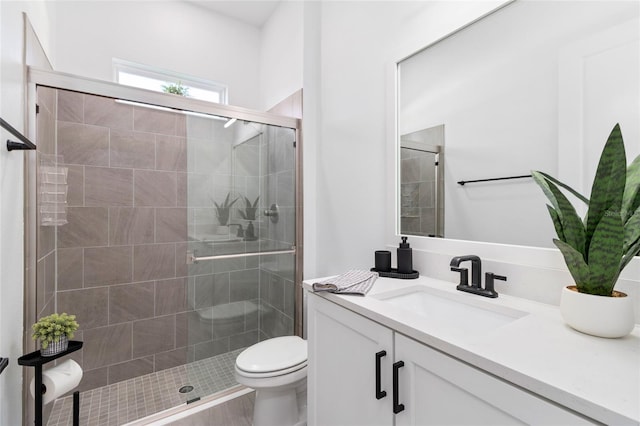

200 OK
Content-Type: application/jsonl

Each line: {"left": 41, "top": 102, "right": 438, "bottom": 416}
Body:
{"left": 0, "top": 1, "right": 55, "bottom": 425}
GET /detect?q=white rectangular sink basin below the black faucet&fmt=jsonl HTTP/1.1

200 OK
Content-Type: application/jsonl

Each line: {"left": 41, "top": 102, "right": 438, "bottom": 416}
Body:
{"left": 373, "top": 286, "right": 528, "bottom": 337}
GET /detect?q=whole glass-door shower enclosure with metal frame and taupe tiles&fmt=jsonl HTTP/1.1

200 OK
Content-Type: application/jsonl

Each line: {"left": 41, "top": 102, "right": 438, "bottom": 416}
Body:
{"left": 26, "top": 69, "right": 302, "bottom": 425}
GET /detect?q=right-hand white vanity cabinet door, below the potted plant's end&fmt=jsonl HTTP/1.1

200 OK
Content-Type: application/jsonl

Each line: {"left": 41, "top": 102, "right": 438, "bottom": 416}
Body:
{"left": 395, "top": 334, "right": 592, "bottom": 426}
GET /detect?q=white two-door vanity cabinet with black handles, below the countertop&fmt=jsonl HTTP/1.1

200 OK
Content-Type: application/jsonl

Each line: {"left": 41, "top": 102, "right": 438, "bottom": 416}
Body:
{"left": 307, "top": 295, "right": 592, "bottom": 426}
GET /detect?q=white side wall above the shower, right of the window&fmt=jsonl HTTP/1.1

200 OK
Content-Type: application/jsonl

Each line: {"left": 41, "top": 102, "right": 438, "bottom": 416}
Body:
{"left": 260, "top": 1, "right": 305, "bottom": 111}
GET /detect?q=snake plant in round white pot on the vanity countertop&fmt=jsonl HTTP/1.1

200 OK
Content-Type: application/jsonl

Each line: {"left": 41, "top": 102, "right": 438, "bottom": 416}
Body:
{"left": 532, "top": 124, "right": 640, "bottom": 338}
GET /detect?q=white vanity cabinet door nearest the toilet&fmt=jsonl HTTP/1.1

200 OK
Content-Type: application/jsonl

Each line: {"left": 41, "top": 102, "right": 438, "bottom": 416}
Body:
{"left": 307, "top": 294, "right": 393, "bottom": 426}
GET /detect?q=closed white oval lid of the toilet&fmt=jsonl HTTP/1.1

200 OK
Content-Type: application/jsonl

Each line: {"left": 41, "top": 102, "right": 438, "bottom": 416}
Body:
{"left": 236, "top": 336, "right": 307, "bottom": 373}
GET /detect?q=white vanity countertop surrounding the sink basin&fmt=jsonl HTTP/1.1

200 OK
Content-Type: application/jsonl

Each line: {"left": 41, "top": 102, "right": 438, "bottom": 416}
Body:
{"left": 304, "top": 277, "right": 640, "bottom": 425}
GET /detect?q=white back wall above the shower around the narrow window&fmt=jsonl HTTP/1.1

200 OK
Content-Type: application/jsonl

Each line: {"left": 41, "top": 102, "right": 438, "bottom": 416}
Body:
{"left": 55, "top": 0, "right": 261, "bottom": 109}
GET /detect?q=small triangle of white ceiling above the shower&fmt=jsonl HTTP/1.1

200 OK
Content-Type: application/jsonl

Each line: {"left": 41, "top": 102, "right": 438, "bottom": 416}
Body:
{"left": 187, "top": 0, "right": 280, "bottom": 28}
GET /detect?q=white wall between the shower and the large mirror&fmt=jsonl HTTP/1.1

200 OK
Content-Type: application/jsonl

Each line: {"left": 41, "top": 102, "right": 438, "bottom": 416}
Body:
{"left": 305, "top": 1, "right": 500, "bottom": 278}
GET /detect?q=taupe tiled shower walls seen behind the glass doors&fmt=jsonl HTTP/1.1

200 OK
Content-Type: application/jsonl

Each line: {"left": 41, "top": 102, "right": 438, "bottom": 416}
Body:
{"left": 31, "top": 87, "right": 295, "bottom": 406}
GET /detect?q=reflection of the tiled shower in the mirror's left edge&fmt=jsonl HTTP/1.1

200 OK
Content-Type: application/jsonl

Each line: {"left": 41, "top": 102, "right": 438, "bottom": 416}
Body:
{"left": 400, "top": 125, "right": 444, "bottom": 237}
